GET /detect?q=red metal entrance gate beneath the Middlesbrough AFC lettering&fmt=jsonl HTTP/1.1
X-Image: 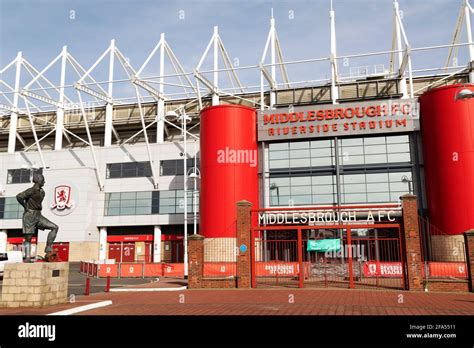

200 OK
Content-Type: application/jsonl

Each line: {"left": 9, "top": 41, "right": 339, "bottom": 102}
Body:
{"left": 251, "top": 224, "right": 406, "bottom": 289}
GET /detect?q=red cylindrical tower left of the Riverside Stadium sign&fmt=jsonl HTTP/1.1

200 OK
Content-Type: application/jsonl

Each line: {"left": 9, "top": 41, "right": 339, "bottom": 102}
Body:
{"left": 199, "top": 105, "right": 258, "bottom": 238}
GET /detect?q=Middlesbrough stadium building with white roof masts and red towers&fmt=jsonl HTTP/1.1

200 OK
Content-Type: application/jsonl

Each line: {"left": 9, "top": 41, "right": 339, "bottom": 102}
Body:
{"left": 0, "top": 1, "right": 474, "bottom": 286}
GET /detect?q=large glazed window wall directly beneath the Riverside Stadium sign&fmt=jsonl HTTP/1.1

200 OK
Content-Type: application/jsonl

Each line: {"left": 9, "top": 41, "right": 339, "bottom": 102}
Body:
{"left": 269, "top": 135, "right": 411, "bottom": 206}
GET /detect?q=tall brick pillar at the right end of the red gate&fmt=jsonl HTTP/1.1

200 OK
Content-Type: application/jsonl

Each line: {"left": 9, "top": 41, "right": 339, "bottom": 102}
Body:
{"left": 400, "top": 194, "right": 423, "bottom": 291}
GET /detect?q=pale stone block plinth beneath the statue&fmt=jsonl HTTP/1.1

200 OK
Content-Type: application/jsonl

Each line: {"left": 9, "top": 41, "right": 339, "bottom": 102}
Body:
{"left": 0, "top": 262, "right": 69, "bottom": 307}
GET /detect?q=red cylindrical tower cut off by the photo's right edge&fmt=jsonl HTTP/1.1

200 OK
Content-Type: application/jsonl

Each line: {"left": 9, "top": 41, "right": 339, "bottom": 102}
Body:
{"left": 420, "top": 85, "right": 474, "bottom": 235}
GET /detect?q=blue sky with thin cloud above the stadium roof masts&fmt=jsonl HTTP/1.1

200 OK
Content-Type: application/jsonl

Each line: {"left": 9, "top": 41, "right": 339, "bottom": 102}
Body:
{"left": 0, "top": 0, "right": 467, "bottom": 100}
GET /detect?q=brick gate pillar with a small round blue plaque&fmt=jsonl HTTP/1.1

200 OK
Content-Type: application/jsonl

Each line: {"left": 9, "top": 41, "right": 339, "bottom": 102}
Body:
{"left": 236, "top": 201, "right": 252, "bottom": 288}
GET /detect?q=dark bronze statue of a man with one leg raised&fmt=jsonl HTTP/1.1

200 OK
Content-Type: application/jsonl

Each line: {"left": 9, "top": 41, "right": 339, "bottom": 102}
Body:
{"left": 16, "top": 174, "right": 58, "bottom": 262}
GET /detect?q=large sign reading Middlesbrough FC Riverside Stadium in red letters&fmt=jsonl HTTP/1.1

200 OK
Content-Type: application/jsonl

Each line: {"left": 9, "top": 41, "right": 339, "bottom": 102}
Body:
{"left": 257, "top": 99, "right": 419, "bottom": 141}
